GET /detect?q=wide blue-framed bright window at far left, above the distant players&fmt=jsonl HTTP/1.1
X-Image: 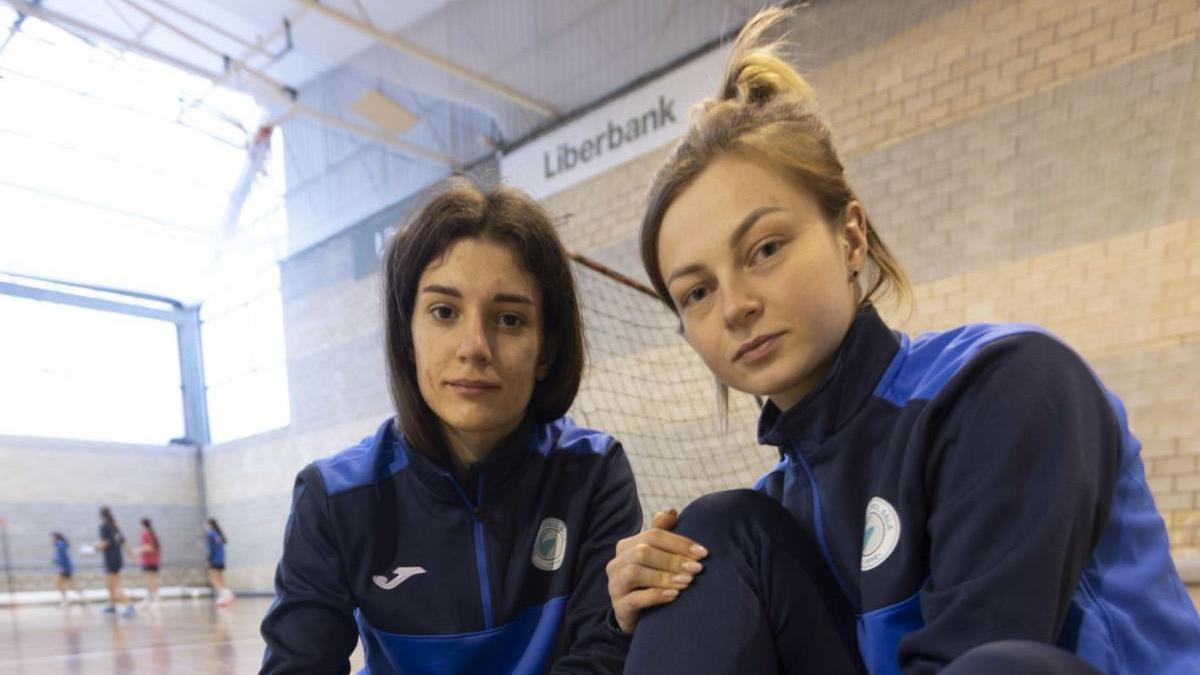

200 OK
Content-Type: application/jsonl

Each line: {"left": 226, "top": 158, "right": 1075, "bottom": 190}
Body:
{"left": 0, "top": 288, "right": 184, "bottom": 444}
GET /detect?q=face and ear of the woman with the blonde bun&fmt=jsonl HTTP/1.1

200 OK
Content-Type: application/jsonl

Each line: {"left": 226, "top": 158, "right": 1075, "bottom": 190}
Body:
{"left": 659, "top": 155, "right": 866, "bottom": 410}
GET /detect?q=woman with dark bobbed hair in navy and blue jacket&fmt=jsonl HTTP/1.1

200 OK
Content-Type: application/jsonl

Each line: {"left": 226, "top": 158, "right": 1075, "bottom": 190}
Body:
{"left": 263, "top": 181, "right": 641, "bottom": 675}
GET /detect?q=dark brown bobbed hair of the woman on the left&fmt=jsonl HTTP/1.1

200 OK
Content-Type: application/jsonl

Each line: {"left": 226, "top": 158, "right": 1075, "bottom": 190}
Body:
{"left": 383, "top": 178, "right": 587, "bottom": 460}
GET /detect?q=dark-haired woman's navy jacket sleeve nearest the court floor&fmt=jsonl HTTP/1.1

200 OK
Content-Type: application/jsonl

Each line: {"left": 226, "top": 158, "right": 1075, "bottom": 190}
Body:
{"left": 260, "top": 466, "right": 358, "bottom": 675}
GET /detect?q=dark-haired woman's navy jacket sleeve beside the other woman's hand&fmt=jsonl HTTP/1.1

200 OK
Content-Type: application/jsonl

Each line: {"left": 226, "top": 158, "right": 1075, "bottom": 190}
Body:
{"left": 551, "top": 442, "right": 642, "bottom": 674}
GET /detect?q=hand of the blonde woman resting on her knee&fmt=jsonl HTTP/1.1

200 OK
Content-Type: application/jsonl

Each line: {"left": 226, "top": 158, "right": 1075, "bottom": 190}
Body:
{"left": 605, "top": 509, "right": 708, "bottom": 633}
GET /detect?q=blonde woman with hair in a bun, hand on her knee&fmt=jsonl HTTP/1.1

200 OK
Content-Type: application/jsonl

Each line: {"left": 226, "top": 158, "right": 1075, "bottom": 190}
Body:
{"left": 608, "top": 10, "right": 1200, "bottom": 675}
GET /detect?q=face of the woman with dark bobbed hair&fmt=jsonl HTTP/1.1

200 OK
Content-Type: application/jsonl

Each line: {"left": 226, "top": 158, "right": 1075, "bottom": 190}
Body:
{"left": 412, "top": 239, "right": 550, "bottom": 447}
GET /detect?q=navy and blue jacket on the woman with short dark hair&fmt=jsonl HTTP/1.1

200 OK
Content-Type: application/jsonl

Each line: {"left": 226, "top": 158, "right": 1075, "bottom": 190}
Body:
{"left": 262, "top": 417, "right": 642, "bottom": 675}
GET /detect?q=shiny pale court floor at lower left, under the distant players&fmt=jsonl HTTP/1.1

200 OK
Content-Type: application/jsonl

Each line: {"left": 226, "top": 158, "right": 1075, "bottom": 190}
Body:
{"left": 0, "top": 598, "right": 362, "bottom": 675}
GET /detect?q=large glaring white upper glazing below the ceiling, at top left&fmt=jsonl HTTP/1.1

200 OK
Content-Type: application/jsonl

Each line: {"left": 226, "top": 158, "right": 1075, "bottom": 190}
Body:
{"left": 0, "top": 6, "right": 287, "bottom": 299}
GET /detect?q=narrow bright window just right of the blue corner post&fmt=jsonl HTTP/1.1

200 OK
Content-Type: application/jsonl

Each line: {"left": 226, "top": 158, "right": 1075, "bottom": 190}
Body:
{"left": 200, "top": 265, "right": 292, "bottom": 443}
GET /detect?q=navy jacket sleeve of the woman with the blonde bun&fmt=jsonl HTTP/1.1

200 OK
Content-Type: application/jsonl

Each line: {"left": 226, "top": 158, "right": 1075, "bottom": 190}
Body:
{"left": 899, "top": 334, "right": 1122, "bottom": 674}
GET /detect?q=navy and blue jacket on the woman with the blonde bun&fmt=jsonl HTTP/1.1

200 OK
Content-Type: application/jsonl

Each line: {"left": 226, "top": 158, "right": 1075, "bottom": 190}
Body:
{"left": 757, "top": 307, "right": 1200, "bottom": 674}
